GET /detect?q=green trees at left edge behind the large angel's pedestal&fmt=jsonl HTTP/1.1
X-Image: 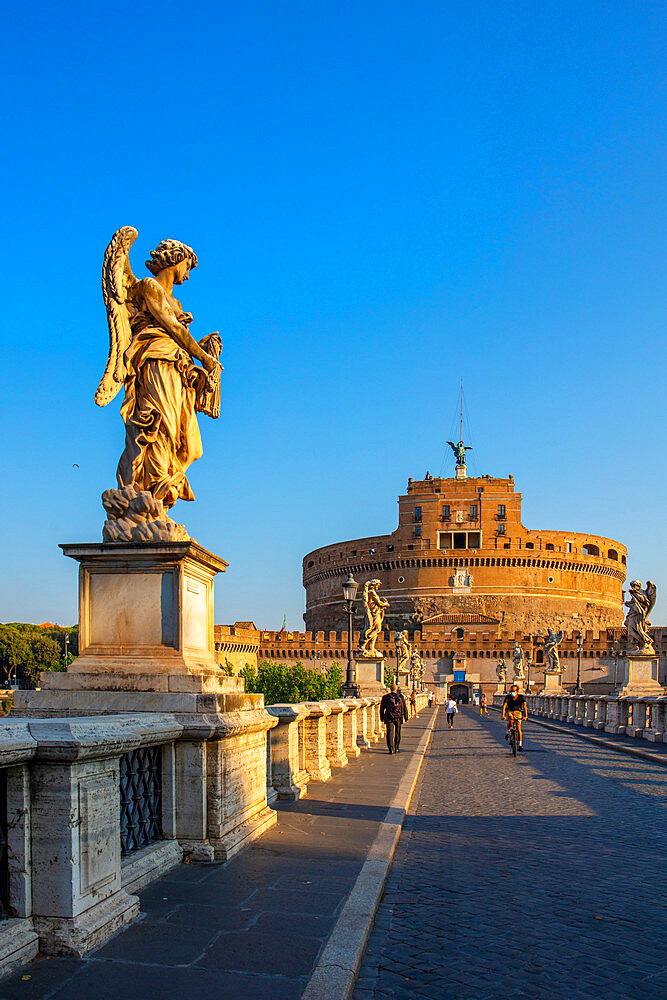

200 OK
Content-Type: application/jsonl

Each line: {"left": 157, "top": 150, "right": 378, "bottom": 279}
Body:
{"left": 0, "top": 622, "right": 79, "bottom": 687}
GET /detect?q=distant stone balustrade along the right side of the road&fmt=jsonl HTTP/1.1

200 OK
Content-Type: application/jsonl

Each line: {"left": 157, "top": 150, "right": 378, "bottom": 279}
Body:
{"left": 528, "top": 694, "right": 667, "bottom": 743}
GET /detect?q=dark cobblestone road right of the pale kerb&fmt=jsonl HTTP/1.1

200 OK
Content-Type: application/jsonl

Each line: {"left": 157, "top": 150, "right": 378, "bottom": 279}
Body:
{"left": 354, "top": 709, "right": 667, "bottom": 1000}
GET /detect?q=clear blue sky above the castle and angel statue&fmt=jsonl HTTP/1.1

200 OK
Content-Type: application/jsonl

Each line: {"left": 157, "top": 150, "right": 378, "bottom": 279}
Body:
{"left": 0, "top": 0, "right": 667, "bottom": 628}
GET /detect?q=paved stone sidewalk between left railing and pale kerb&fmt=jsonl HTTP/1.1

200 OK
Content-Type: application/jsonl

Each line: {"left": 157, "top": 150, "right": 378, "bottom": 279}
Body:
{"left": 0, "top": 710, "right": 433, "bottom": 1000}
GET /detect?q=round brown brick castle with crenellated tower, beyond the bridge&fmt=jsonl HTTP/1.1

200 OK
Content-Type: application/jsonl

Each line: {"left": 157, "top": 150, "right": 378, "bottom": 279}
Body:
{"left": 303, "top": 456, "right": 627, "bottom": 631}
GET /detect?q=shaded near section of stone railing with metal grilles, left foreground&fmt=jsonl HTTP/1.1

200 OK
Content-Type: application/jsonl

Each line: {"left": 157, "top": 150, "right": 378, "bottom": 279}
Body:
{"left": 0, "top": 714, "right": 188, "bottom": 972}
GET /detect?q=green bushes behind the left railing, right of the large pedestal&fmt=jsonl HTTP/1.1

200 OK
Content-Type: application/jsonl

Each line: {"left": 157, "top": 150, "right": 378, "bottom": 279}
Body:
{"left": 239, "top": 660, "right": 343, "bottom": 705}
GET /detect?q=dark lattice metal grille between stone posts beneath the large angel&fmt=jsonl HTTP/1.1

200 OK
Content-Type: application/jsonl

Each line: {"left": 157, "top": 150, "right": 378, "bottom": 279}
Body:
{"left": 120, "top": 746, "right": 162, "bottom": 855}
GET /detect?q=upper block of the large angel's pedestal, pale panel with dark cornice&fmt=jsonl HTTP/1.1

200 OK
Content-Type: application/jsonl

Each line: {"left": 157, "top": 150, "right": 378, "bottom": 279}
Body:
{"left": 47, "top": 541, "right": 227, "bottom": 693}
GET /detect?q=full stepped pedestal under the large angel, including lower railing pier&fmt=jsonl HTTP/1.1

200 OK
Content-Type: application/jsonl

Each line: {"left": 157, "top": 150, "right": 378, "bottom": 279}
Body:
{"left": 13, "top": 540, "right": 278, "bottom": 861}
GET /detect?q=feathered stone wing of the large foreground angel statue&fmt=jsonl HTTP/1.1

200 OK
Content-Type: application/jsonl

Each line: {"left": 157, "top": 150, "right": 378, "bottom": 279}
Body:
{"left": 95, "top": 226, "right": 138, "bottom": 406}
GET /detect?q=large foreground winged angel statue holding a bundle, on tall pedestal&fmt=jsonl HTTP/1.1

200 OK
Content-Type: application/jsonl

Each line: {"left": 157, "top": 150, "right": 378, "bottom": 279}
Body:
{"left": 95, "top": 226, "right": 222, "bottom": 541}
